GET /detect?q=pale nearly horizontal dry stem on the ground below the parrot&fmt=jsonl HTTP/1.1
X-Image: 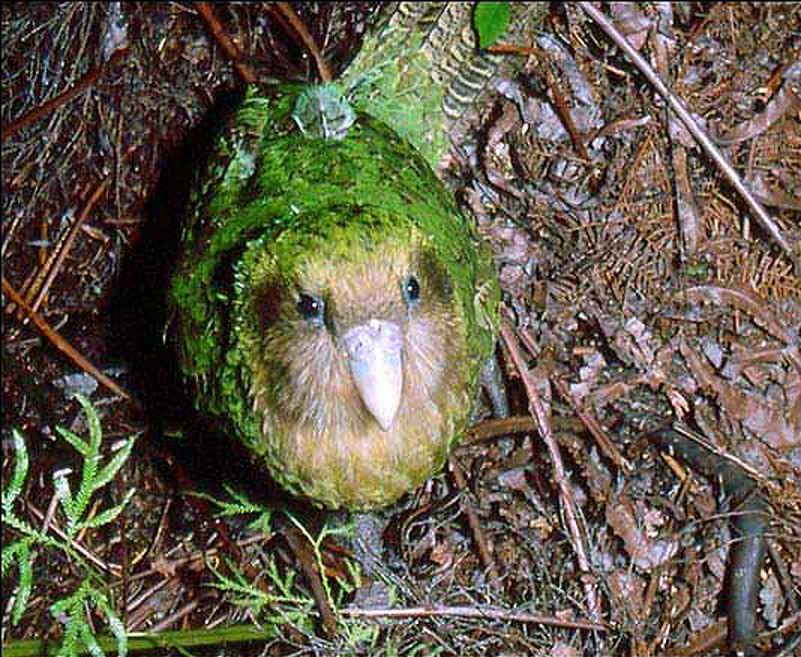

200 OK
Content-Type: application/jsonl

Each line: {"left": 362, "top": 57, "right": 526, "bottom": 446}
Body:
{"left": 341, "top": 605, "right": 609, "bottom": 632}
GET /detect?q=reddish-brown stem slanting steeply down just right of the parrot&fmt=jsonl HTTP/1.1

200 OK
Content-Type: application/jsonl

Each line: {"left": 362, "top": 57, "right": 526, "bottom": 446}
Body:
{"left": 501, "top": 321, "right": 601, "bottom": 619}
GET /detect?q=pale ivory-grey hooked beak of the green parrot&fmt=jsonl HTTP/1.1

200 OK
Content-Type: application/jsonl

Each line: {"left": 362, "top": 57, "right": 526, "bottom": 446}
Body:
{"left": 343, "top": 319, "right": 403, "bottom": 431}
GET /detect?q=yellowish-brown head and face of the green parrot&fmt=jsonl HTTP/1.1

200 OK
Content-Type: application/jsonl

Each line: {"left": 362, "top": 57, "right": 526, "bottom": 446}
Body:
{"left": 228, "top": 217, "right": 471, "bottom": 506}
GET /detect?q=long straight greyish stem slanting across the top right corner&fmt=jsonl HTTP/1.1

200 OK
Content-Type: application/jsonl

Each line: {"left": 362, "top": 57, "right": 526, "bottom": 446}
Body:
{"left": 578, "top": 2, "right": 801, "bottom": 274}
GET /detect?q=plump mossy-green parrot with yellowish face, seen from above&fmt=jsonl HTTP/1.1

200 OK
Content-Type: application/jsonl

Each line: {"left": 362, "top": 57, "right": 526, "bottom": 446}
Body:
{"left": 168, "top": 3, "right": 536, "bottom": 511}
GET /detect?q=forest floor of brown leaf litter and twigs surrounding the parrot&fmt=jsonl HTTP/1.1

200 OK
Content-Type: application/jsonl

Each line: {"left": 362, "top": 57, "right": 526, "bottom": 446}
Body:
{"left": 0, "top": 2, "right": 801, "bottom": 657}
